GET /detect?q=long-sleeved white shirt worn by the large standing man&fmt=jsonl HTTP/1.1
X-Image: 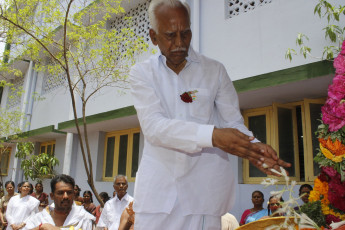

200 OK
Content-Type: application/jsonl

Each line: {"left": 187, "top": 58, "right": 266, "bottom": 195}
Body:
{"left": 130, "top": 48, "right": 252, "bottom": 216}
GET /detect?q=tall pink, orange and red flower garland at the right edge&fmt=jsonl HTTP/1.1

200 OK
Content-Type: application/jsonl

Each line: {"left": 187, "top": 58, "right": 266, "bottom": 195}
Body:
{"left": 309, "top": 41, "right": 345, "bottom": 227}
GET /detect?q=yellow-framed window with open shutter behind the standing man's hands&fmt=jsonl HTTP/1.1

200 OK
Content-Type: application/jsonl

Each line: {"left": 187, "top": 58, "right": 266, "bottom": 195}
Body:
{"left": 243, "top": 99, "right": 325, "bottom": 183}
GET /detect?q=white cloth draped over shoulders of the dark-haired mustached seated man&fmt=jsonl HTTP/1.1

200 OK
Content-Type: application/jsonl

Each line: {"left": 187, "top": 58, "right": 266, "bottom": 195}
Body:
{"left": 23, "top": 205, "right": 96, "bottom": 230}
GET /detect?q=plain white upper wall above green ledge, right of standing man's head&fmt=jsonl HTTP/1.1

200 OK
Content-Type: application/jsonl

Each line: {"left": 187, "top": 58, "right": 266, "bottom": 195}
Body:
{"left": 200, "top": 0, "right": 345, "bottom": 80}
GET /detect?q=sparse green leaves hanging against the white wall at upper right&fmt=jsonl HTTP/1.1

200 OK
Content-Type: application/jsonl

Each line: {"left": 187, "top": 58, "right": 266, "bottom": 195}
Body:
{"left": 285, "top": 0, "right": 345, "bottom": 61}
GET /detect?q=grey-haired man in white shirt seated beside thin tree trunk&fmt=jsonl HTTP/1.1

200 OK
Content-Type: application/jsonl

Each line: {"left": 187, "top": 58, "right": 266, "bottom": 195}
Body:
{"left": 97, "top": 175, "right": 133, "bottom": 230}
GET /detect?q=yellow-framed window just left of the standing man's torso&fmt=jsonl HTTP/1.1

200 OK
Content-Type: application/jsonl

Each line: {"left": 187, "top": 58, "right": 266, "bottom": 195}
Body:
{"left": 103, "top": 128, "right": 140, "bottom": 182}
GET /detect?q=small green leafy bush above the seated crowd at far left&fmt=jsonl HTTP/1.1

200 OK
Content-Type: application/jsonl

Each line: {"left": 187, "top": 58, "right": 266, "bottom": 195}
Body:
{"left": 15, "top": 142, "right": 59, "bottom": 180}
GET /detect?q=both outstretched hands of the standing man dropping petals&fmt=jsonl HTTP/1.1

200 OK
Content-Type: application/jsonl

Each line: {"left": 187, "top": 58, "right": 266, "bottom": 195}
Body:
{"left": 212, "top": 128, "right": 291, "bottom": 174}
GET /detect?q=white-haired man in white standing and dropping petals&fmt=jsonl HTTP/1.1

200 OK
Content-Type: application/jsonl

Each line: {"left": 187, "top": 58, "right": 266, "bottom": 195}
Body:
{"left": 130, "top": 0, "right": 289, "bottom": 230}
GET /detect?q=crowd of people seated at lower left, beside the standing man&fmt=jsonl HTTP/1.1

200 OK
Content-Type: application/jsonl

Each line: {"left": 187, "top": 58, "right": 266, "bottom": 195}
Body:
{"left": 0, "top": 174, "right": 125, "bottom": 230}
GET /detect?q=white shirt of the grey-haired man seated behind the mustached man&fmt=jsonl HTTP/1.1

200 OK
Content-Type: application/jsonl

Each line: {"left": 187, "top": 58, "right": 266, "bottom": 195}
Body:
{"left": 97, "top": 193, "right": 133, "bottom": 230}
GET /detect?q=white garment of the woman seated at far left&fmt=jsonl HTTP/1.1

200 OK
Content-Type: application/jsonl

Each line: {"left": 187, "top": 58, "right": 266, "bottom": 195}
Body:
{"left": 6, "top": 195, "right": 40, "bottom": 230}
